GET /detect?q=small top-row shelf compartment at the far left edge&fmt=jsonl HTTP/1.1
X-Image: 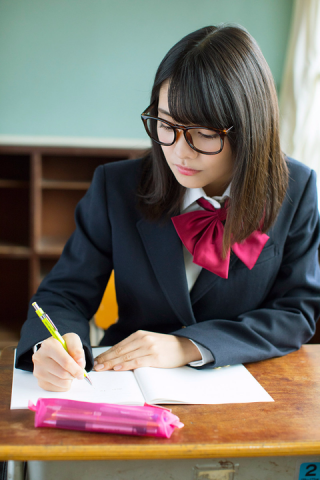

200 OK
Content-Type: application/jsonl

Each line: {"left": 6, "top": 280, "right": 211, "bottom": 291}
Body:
{"left": 0, "top": 153, "right": 30, "bottom": 183}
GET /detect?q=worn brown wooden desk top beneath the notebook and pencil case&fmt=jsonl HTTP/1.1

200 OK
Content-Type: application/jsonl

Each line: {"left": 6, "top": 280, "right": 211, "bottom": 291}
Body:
{"left": 0, "top": 345, "right": 320, "bottom": 460}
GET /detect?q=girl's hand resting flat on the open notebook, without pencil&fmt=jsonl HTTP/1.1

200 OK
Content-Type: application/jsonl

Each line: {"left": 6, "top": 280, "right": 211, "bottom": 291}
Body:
{"left": 94, "top": 330, "right": 201, "bottom": 372}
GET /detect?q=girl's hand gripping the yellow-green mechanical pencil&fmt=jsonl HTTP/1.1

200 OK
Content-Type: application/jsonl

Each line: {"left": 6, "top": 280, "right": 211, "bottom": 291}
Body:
{"left": 32, "top": 333, "right": 85, "bottom": 392}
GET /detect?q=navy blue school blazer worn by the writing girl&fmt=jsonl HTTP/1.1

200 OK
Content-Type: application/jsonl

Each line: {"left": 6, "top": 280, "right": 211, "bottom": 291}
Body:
{"left": 16, "top": 160, "right": 320, "bottom": 371}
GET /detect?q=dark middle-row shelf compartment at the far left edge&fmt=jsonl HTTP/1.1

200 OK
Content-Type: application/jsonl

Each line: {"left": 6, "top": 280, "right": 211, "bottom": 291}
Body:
{"left": 0, "top": 188, "right": 30, "bottom": 247}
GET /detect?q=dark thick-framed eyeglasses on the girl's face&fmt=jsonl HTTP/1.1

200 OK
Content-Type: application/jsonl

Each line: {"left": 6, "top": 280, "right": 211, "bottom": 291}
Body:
{"left": 141, "top": 106, "right": 233, "bottom": 155}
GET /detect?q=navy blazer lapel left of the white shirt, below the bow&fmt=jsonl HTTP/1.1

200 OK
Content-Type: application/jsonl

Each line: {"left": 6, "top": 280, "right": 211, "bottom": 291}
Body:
{"left": 137, "top": 219, "right": 196, "bottom": 326}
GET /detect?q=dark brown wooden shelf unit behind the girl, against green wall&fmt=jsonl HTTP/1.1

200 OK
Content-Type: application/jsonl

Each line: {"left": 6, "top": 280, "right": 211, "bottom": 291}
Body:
{"left": 0, "top": 145, "right": 144, "bottom": 343}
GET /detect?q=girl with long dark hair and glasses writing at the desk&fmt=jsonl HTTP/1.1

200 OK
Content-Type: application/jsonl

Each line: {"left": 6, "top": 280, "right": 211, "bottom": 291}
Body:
{"left": 16, "top": 25, "right": 320, "bottom": 390}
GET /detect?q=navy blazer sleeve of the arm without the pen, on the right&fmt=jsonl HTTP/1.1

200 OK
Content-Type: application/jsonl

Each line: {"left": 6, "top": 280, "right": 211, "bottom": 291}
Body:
{"left": 173, "top": 172, "right": 320, "bottom": 368}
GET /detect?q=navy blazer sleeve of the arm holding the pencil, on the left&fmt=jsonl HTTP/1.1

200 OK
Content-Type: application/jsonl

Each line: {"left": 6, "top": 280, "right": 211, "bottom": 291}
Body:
{"left": 16, "top": 166, "right": 113, "bottom": 371}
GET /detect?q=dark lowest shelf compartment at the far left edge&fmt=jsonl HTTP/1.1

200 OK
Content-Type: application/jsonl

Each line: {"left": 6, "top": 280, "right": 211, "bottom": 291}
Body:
{"left": 0, "top": 258, "right": 29, "bottom": 341}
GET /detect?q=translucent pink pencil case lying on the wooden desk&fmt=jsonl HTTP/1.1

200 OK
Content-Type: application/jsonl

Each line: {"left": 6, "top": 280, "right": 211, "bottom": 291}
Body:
{"left": 29, "top": 398, "right": 184, "bottom": 438}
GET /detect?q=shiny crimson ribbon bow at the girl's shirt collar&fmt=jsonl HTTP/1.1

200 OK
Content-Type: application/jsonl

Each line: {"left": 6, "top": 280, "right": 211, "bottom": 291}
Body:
{"left": 171, "top": 198, "right": 269, "bottom": 278}
